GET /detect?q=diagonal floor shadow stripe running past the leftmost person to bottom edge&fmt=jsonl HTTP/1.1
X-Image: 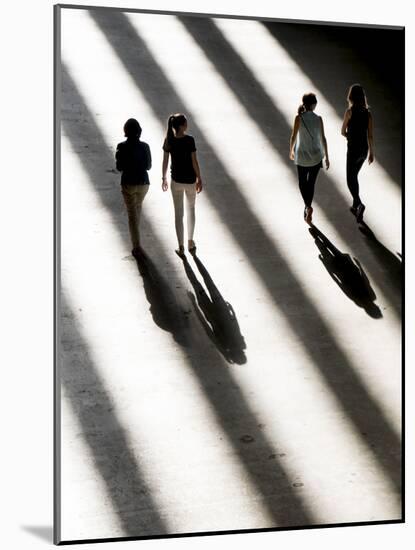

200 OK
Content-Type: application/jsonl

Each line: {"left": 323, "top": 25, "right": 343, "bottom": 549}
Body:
{"left": 62, "top": 62, "right": 316, "bottom": 536}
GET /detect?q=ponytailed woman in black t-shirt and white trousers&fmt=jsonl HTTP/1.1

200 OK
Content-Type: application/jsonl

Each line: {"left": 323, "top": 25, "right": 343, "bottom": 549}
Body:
{"left": 162, "top": 113, "right": 202, "bottom": 256}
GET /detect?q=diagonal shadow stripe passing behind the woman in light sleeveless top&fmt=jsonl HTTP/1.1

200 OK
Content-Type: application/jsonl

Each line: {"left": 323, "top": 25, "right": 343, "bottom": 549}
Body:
{"left": 179, "top": 17, "right": 401, "bottom": 318}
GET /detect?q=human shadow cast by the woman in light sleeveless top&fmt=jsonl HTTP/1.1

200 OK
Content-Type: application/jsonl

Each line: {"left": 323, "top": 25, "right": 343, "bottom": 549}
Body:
{"left": 309, "top": 225, "right": 382, "bottom": 319}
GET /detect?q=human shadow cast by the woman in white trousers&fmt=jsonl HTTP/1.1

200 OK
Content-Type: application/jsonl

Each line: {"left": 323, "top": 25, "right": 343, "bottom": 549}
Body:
{"left": 182, "top": 254, "right": 247, "bottom": 365}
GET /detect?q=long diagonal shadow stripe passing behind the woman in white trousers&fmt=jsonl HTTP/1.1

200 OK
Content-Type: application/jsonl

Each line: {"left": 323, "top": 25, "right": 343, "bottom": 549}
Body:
{"left": 90, "top": 10, "right": 401, "bottom": 494}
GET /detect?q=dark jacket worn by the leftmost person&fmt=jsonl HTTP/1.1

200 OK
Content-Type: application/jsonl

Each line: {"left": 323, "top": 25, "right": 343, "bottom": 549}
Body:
{"left": 115, "top": 137, "right": 151, "bottom": 185}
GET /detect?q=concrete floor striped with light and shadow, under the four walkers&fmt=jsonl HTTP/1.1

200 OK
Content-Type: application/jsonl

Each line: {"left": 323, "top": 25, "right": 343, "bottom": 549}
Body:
{"left": 59, "top": 9, "right": 402, "bottom": 540}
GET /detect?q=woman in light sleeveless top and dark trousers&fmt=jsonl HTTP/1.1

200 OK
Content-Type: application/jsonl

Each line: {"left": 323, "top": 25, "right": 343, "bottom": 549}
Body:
{"left": 290, "top": 93, "right": 330, "bottom": 225}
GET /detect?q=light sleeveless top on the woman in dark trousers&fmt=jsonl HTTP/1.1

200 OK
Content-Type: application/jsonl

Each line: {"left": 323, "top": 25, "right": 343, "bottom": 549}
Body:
{"left": 294, "top": 111, "right": 324, "bottom": 166}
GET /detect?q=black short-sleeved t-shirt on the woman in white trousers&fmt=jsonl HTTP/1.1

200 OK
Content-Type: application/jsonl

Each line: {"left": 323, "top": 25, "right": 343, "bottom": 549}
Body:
{"left": 163, "top": 135, "right": 196, "bottom": 183}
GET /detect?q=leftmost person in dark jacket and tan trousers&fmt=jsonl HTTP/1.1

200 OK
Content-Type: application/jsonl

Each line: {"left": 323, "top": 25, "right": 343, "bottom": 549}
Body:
{"left": 115, "top": 118, "right": 151, "bottom": 256}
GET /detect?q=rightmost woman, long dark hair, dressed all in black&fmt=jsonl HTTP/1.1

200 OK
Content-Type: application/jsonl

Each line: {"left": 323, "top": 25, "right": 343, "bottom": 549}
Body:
{"left": 341, "top": 84, "right": 374, "bottom": 223}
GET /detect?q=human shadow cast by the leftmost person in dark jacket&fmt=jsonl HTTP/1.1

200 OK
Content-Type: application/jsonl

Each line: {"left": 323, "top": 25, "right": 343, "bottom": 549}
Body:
{"left": 136, "top": 253, "right": 189, "bottom": 347}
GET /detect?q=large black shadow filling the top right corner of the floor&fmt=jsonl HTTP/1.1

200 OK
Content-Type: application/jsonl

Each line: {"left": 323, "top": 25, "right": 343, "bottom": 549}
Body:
{"left": 263, "top": 22, "right": 405, "bottom": 190}
